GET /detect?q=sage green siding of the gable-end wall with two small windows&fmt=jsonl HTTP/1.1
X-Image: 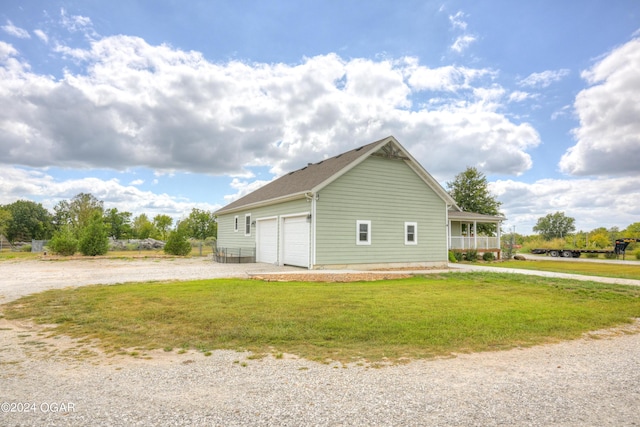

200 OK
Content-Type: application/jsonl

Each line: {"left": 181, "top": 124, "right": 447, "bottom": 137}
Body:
{"left": 316, "top": 157, "right": 447, "bottom": 265}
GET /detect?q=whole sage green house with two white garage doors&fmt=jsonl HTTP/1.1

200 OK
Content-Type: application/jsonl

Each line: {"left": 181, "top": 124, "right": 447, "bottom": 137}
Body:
{"left": 216, "top": 136, "right": 502, "bottom": 269}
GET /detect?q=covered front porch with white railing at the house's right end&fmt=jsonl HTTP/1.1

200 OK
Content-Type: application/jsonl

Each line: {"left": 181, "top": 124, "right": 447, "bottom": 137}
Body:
{"left": 449, "top": 210, "right": 506, "bottom": 259}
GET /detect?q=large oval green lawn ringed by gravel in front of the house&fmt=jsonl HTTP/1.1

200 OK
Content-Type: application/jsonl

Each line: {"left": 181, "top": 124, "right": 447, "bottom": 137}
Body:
{"left": 2, "top": 273, "right": 640, "bottom": 362}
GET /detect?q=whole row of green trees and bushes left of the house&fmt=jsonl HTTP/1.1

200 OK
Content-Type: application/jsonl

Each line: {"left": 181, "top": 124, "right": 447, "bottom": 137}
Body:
{"left": 0, "top": 193, "right": 218, "bottom": 255}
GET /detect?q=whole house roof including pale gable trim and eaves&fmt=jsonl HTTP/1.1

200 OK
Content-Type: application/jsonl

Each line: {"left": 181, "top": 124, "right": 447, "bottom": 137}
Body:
{"left": 216, "top": 136, "right": 455, "bottom": 214}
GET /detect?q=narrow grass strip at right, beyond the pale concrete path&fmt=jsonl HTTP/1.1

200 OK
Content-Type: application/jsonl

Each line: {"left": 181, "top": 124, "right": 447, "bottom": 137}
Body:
{"left": 491, "top": 260, "right": 640, "bottom": 280}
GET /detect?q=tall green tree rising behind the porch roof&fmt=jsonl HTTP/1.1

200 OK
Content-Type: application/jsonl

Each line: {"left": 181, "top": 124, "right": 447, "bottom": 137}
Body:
{"left": 447, "top": 167, "right": 502, "bottom": 235}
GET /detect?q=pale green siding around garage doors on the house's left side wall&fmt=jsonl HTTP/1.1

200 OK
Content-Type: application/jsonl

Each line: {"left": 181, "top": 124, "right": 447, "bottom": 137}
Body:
{"left": 217, "top": 196, "right": 311, "bottom": 248}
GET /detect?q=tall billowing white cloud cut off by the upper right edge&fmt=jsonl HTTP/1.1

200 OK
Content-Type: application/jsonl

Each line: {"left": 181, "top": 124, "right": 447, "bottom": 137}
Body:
{"left": 560, "top": 38, "right": 640, "bottom": 176}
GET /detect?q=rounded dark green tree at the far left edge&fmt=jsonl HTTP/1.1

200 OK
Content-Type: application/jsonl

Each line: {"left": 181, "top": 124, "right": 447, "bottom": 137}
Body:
{"left": 2, "top": 200, "right": 53, "bottom": 242}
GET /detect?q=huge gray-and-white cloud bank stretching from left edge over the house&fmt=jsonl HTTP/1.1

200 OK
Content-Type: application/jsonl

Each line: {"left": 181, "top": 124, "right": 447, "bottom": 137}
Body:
{"left": 0, "top": 36, "right": 540, "bottom": 179}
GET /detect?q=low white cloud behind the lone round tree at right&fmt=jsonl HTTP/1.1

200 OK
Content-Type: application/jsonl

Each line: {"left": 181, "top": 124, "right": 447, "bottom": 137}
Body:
{"left": 489, "top": 177, "right": 640, "bottom": 234}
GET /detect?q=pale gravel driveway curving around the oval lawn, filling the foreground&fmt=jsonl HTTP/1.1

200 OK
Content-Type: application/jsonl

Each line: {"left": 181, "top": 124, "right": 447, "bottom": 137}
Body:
{"left": 0, "top": 259, "right": 640, "bottom": 426}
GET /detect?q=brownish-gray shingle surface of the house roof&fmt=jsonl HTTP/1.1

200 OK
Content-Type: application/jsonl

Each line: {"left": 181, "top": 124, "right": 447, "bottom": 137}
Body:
{"left": 215, "top": 136, "right": 458, "bottom": 215}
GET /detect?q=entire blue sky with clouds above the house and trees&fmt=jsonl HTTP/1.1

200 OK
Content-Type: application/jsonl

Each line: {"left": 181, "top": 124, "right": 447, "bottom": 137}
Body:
{"left": 0, "top": 0, "right": 640, "bottom": 234}
